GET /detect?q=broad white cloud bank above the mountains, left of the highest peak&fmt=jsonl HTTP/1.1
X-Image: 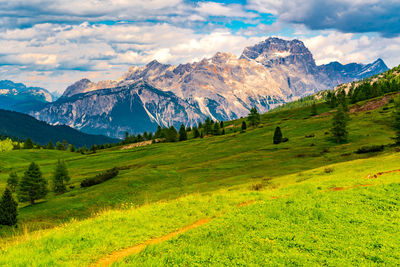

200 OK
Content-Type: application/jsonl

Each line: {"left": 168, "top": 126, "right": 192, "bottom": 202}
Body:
{"left": 0, "top": 22, "right": 261, "bottom": 91}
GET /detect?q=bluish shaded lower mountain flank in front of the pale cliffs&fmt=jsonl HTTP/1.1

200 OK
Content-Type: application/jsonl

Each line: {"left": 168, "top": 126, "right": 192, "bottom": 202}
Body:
{"left": 32, "top": 82, "right": 205, "bottom": 137}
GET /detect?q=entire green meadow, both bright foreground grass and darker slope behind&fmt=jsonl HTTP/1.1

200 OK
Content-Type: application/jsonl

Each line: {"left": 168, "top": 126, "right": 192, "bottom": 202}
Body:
{"left": 0, "top": 96, "right": 400, "bottom": 266}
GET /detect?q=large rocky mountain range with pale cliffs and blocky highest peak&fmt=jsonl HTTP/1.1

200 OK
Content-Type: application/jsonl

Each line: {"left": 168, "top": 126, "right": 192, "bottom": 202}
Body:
{"left": 2, "top": 38, "right": 388, "bottom": 137}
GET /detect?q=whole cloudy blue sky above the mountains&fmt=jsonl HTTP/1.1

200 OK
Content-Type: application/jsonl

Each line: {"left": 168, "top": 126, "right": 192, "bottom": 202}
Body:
{"left": 0, "top": 0, "right": 400, "bottom": 94}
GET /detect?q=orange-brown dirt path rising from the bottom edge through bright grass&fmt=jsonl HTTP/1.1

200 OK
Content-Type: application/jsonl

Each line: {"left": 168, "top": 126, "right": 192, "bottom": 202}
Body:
{"left": 91, "top": 200, "right": 254, "bottom": 267}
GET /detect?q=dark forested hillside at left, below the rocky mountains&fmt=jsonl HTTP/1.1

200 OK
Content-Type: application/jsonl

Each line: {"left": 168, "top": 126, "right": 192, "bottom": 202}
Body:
{"left": 0, "top": 109, "right": 119, "bottom": 147}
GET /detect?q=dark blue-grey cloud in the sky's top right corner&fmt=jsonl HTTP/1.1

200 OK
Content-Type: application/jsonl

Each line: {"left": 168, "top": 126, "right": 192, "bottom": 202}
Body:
{"left": 249, "top": 0, "right": 400, "bottom": 37}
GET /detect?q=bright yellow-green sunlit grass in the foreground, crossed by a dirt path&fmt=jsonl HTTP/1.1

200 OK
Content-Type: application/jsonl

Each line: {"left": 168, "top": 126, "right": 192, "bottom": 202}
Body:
{"left": 0, "top": 154, "right": 400, "bottom": 266}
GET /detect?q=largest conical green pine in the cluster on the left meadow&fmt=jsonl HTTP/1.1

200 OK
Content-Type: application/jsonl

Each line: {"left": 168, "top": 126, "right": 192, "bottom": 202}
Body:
{"left": 18, "top": 162, "right": 48, "bottom": 204}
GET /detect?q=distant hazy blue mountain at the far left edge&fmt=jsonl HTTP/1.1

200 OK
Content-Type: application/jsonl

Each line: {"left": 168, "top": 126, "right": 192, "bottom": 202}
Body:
{"left": 0, "top": 80, "right": 54, "bottom": 111}
